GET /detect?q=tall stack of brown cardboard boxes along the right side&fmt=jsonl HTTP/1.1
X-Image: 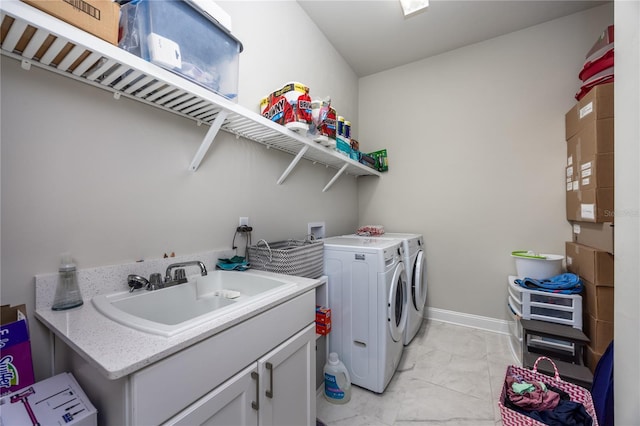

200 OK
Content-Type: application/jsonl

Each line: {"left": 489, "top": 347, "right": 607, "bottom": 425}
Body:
{"left": 565, "top": 83, "right": 614, "bottom": 371}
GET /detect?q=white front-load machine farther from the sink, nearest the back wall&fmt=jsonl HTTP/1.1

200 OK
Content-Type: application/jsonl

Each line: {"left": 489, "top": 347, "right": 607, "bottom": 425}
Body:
{"left": 345, "top": 232, "right": 427, "bottom": 345}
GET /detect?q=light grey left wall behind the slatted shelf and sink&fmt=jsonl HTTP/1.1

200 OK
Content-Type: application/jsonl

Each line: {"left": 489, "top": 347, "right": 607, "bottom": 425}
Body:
{"left": 0, "top": 2, "right": 358, "bottom": 378}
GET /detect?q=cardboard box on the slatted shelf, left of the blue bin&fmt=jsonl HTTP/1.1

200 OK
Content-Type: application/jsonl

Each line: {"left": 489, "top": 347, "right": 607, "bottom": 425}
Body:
{"left": 22, "top": 0, "right": 120, "bottom": 45}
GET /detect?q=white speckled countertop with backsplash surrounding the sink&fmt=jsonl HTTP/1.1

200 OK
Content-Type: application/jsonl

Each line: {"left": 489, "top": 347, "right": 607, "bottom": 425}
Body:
{"left": 35, "top": 253, "right": 324, "bottom": 379}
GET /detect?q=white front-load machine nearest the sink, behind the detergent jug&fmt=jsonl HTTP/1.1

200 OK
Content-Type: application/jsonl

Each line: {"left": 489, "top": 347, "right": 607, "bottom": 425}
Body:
{"left": 323, "top": 237, "right": 408, "bottom": 393}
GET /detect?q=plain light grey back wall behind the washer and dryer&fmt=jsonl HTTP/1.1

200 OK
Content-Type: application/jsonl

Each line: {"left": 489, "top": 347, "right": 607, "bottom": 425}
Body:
{"left": 358, "top": 4, "right": 613, "bottom": 319}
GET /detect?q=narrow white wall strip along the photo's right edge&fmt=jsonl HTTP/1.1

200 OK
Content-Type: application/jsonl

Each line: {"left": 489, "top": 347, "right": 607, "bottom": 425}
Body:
{"left": 614, "top": 1, "right": 640, "bottom": 425}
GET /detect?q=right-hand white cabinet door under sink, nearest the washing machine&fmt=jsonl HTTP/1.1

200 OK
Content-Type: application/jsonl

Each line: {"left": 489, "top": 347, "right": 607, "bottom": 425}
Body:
{"left": 258, "top": 324, "right": 316, "bottom": 426}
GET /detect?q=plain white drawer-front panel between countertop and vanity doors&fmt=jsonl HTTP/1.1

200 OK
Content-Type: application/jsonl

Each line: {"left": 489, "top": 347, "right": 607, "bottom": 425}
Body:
{"left": 131, "top": 291, "right": 315, "bottom": 425}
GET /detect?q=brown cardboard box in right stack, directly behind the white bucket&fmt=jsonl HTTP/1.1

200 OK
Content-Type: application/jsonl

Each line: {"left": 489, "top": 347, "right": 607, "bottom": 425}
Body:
{"left": 565, "top": 241, "right": 614, "bottom": 287}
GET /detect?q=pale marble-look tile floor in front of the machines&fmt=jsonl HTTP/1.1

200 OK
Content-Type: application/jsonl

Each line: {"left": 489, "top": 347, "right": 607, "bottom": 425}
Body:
{"left": 317, "top": 320, "right": 516, "bottom": 426}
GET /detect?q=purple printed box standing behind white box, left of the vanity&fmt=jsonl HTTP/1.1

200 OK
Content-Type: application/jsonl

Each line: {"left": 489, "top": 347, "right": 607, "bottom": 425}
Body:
{"left": 0, "top": 305, "right": 35, "bottom": 395}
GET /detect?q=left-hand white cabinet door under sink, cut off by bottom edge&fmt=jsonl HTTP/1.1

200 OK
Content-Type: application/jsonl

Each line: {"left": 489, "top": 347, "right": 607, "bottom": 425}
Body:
{"left": 164, "top": 363, "right": 258, "bottom": 426}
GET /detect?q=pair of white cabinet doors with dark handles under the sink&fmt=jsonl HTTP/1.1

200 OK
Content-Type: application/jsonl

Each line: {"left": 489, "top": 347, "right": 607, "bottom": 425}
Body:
{"left": 164, "top": 325, "right": 315, "bottom": 426}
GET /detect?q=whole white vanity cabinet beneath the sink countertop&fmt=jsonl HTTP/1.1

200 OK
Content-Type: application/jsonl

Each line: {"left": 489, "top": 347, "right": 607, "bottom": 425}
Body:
{"left": 63, "top": 289, "right": 316, "bottom": 426}
